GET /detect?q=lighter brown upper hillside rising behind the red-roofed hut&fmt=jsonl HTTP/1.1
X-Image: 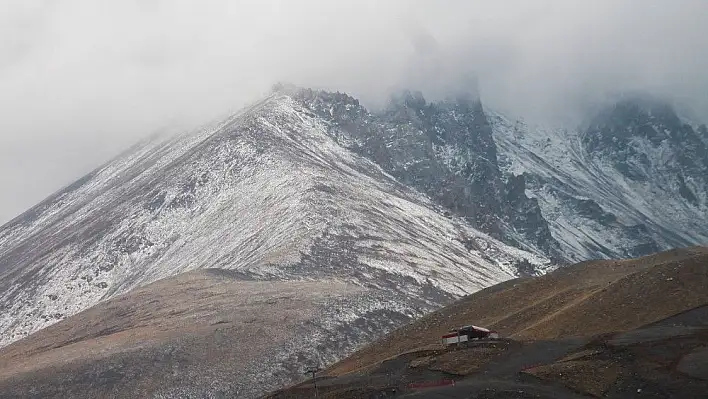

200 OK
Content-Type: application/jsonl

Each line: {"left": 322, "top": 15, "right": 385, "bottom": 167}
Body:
{"left": 327, "top": 247, "right": 708, "bottom": 376}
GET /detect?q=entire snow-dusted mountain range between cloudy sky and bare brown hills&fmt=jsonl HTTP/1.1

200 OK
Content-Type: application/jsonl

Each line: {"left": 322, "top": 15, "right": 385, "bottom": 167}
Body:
{"left": 0, "top": 85, "right": 708, "bottom": 394}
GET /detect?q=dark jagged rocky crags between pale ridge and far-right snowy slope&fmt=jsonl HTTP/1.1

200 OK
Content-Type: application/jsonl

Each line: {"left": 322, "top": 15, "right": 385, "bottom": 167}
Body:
{"left": 280, "top": 89, "right": 555, "bottom": 268}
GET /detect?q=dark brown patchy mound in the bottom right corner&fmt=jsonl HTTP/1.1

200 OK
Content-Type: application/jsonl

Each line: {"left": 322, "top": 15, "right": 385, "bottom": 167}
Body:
{"left": 522, "top": 305, "right": 708, "bottom": 399}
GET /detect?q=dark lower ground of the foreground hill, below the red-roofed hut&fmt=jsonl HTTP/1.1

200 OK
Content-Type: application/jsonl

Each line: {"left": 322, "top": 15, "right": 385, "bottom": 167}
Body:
{"left": 269, "top": 314, "right": 708, "bottom": 399}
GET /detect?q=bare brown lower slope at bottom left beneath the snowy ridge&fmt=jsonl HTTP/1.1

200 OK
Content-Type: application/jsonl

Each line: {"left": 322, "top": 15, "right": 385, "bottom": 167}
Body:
{"left": 0, "top": 270, "right": 360, "bottom": 398}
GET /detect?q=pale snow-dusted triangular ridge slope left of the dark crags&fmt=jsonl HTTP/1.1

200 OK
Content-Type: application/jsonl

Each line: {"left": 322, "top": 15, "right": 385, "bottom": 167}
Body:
{"left": 0, "top": 94, "right": 547, "bottom": 355}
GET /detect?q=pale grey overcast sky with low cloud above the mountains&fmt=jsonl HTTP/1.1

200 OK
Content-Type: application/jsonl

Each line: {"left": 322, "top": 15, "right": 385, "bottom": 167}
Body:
{"left": 0, "top": 0, "right": 708, "bottom": 223}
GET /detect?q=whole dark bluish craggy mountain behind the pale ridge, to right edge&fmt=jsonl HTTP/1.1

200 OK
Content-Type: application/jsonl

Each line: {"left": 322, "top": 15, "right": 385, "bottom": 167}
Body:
{"left": 281, "top": 87, "right": 708, "bottom": 266}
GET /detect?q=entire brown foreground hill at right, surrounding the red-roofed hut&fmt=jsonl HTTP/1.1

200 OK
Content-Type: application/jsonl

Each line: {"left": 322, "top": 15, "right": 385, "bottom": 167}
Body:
{"left": 268, "top": 247, "right": 708, "bottom": 399}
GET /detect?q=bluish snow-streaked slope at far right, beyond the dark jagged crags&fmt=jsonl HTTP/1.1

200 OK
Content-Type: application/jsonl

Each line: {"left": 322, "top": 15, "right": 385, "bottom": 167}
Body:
{"left": 487, "top": 98, "right": 708, "bottom": 261}
